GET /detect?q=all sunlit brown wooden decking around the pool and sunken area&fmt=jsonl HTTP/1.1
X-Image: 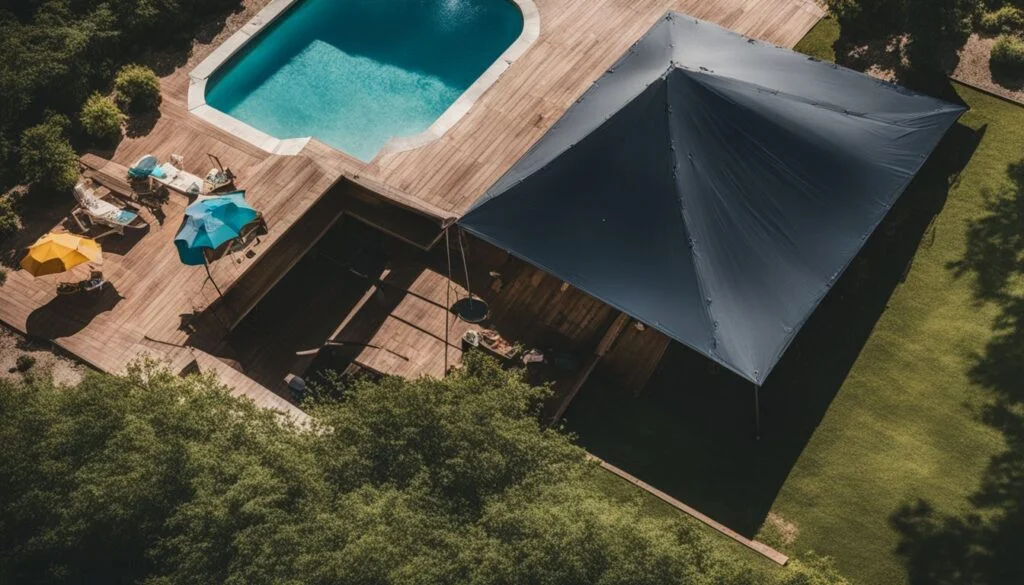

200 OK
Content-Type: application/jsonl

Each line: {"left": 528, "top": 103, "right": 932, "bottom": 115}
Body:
{"left": 0, "top": 0, "right": 823, "bottom": 410}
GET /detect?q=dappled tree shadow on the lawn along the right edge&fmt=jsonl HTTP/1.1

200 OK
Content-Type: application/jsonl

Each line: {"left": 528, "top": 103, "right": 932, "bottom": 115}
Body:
{"left": 890, "top": 162, "right": 1024, "bottom": 585}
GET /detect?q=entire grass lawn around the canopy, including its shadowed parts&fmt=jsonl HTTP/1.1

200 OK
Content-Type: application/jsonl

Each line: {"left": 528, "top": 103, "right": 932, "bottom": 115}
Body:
{"left": 567, "top": 20, "right": 1024, "bottom": 585}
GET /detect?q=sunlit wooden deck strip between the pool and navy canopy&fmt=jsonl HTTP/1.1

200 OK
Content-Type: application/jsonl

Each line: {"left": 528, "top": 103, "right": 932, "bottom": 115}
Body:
{"left": 368, "top": 0, "right": 823, "bottom": 215}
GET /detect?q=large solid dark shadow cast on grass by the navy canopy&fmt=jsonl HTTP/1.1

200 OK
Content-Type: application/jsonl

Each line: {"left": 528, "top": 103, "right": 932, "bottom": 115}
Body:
{"left": 565, "top": 125, "right": 985, "bottom": 537}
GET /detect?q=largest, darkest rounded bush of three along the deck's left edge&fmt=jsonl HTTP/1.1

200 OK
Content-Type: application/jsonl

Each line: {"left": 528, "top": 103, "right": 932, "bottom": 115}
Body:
{"left": 20, "top": 116, "right": 78, "bottom": 191}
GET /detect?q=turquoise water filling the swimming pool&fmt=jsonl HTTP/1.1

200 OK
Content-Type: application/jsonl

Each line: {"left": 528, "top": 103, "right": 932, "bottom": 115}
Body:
{"left": 206, "top": 0, "right": 523, "bottom": 161}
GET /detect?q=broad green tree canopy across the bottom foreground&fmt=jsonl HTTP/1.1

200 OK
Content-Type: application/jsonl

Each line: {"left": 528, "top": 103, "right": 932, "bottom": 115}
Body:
{"left": 0, "top": 357, "right": 845, "bottom": 585}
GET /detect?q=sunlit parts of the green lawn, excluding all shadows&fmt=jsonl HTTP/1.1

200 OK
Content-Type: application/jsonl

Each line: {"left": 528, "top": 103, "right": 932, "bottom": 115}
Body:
{"left": 772, "top": 20, "right": 1011, "bottom": 583}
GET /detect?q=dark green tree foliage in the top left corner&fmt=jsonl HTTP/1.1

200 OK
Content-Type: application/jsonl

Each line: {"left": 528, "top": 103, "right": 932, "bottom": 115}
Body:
{"left": 0, "top": 0, "right": 240, "bottom": 192}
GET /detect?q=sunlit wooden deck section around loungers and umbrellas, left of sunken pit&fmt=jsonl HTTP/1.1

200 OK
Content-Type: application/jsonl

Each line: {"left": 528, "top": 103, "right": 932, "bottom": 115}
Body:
{"left": 0, "top": 78, "right": 341, "bottom": 407}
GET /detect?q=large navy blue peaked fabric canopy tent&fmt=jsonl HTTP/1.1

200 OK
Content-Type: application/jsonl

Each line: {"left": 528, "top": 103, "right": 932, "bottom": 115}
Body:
{"left": 459, "top": 12, "right": 965, "bottom": 436}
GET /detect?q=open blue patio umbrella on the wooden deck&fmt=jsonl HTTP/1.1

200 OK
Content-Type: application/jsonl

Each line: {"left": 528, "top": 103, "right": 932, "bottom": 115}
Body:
{"left": 174, "top": 191, "right": 257, "bottom": 266}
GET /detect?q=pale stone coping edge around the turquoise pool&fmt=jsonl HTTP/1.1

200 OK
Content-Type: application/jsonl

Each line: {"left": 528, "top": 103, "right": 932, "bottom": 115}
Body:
{"left": 186, "top": 0, "right": 541, "bottom": 159}
